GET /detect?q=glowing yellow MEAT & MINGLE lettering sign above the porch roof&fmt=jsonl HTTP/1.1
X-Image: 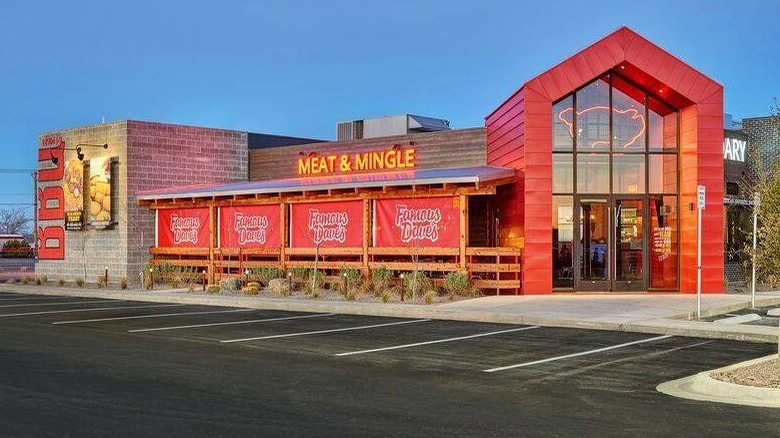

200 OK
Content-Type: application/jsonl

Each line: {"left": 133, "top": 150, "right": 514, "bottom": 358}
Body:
{"left": 298, "top": 148, "right": 417, "bottom": 176}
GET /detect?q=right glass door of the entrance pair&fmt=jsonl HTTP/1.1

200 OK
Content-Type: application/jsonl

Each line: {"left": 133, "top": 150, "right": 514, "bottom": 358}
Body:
{"left": 611, "top": 198, "right": 647, "bottom": 291}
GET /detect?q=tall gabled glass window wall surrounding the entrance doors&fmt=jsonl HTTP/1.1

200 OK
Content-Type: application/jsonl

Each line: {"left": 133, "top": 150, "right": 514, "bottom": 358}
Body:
{"left": 552, "top": 72, "right": 679, "bottom": 290}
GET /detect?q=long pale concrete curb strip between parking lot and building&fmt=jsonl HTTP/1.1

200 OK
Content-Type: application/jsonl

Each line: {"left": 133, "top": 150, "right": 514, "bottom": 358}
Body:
{"left": 0, "top": 284, "right": 780, "bottom": 343}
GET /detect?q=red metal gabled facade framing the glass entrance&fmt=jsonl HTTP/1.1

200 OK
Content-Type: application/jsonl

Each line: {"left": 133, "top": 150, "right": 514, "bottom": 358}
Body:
{"left": 486, "top": 27, "right": 724, "bottom": 294}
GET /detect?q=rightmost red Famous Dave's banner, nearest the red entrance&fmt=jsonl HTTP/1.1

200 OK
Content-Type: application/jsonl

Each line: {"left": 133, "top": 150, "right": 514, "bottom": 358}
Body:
{"left": 374, "top": 197, "right": 460, "bottom": 248}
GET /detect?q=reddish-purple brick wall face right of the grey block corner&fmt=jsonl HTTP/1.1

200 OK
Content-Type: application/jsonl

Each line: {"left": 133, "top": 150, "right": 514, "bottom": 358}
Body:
{"left": 125, "top": 120, "right": 248, "bottom": 281}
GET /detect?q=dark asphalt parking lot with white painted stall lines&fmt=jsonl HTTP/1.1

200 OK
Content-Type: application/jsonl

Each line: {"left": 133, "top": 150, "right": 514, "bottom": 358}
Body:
{"left": 0, "top": 293, "right": 780, "bottom": 436}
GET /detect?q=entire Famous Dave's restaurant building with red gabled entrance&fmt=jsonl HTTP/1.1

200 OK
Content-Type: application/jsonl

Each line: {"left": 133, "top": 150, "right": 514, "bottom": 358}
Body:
{"left": 39, "top": 28, "right": 732, "bottom": 294}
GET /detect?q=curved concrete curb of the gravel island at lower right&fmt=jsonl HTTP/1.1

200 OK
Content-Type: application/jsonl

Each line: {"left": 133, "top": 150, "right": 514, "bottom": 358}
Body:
{"left": 656, "top": 354, "right": 780, "bottom": 408}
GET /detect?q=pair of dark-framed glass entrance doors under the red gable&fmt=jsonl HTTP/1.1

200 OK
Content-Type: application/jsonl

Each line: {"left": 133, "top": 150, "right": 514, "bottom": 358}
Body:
{"left": 574, "top": 196, "right": 647, "bottom": 291}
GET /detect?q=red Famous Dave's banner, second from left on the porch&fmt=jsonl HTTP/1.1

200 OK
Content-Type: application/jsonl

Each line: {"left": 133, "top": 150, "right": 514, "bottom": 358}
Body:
{"left": 219, "top": 204, "right": 281, "bottom": 248}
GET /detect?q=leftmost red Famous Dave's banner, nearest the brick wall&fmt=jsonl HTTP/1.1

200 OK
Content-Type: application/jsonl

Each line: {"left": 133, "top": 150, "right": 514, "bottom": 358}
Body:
{"left": 157, "top": 208, "right": 209, "bottom": 248}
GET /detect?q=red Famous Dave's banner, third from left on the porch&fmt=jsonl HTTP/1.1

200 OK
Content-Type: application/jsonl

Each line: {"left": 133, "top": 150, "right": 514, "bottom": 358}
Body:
{"left": 290, "top": 201, "right": 363, "bottom": 248}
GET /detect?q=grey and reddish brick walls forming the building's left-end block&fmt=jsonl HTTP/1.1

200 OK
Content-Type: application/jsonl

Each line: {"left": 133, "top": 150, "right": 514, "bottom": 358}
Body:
{"left": 36, "top": 121, "right": 248, "bottom": 283}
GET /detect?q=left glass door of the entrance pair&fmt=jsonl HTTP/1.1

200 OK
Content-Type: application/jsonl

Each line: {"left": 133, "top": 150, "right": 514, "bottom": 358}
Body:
{"left": 574, "top": 197, "right": 612, "bottom": 291}
